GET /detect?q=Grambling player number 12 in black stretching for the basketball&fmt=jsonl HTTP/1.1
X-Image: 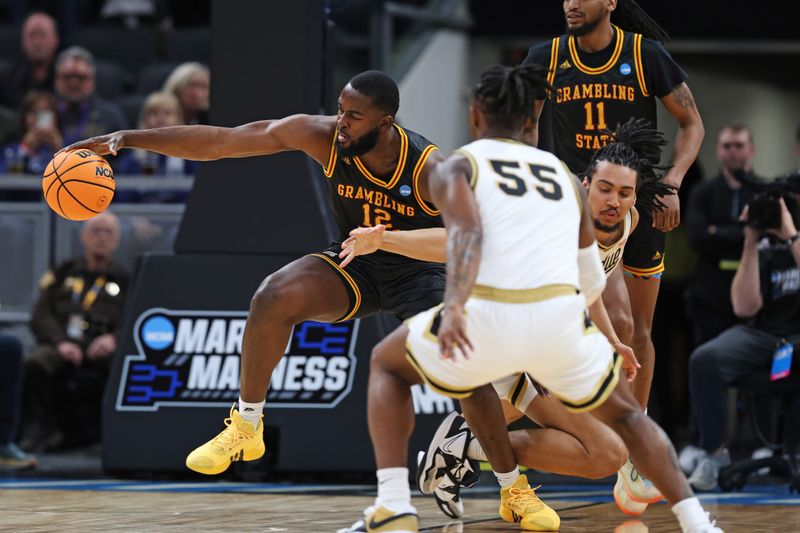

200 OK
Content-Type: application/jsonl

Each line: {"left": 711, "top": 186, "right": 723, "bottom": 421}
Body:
{"left": 66, "top": 71, "right": 445, "bottom": 474}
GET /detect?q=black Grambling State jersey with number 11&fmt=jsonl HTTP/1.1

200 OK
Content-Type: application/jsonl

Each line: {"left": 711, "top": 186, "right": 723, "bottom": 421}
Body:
{"left": 536, "top": 26, "right": 656, "bottom": 173}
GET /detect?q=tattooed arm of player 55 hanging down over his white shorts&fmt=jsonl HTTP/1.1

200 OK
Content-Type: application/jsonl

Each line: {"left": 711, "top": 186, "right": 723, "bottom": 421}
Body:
{"left": 429, "top": 154, "right": 483, "bottom": 359}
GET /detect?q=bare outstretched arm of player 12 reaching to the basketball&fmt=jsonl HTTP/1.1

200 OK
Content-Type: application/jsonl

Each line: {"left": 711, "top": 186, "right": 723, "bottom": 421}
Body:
{"left": 64, "top": 115, "right": 336, "bottom": 165}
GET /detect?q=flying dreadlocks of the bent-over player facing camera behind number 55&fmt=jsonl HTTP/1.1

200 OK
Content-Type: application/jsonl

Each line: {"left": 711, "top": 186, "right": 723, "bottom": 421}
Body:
{"left": 583, "top": 118, "right": 675, "bottom": 212}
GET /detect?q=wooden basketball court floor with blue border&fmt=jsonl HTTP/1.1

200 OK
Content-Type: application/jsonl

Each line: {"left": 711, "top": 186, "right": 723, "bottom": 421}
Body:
{"left": 0, "top": 462, "right": 800, "bottom": 533}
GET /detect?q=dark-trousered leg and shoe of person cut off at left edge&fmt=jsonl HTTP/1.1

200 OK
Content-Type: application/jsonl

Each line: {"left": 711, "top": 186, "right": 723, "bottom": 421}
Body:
{"left": 0, "top": 333, "right": 36, "bottom": 469}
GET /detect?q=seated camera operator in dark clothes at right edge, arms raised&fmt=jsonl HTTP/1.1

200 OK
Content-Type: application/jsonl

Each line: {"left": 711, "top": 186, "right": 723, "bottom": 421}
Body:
{"left": 689, "top": 193, "right": 800, "bottom": 490}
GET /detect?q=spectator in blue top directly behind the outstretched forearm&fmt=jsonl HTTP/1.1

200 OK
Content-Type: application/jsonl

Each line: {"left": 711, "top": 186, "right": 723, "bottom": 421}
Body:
{"left": 114, "top": 91, "right": 197, "bottom": 203}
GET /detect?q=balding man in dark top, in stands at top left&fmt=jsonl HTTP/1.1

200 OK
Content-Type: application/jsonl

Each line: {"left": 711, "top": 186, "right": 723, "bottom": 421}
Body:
{"left": 0, "top": 12, "right": 59, "bottom": 108}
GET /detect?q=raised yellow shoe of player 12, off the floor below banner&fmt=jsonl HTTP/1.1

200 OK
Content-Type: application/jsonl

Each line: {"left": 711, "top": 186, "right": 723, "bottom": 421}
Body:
{"left": 186, "top": 406, "right": 265, "bottom": 476}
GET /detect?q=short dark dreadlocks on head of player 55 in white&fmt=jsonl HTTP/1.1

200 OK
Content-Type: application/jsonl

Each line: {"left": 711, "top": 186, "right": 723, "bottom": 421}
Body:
{"left": 472, "top": 64, "right": 551, "bottom": 129}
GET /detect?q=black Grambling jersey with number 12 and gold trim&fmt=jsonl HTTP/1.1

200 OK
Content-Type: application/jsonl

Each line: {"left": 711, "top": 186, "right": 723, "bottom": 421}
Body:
{"left": 323, "top": 124, "right": 443, "bottom": 264}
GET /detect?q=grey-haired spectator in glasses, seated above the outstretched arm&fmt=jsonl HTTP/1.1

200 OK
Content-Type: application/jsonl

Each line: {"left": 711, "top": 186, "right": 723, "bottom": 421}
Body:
{"left": 55, "top": 46, "right": 128, "bottom": 145}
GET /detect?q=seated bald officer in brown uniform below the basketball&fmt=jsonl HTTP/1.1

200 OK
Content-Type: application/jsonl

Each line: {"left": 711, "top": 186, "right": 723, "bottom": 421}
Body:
{"left": 21, "top": 212, "right": 128, "bottom": 451}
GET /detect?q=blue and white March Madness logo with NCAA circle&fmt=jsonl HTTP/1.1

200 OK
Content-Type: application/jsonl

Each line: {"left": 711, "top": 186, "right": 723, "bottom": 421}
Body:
{"left": 116, "top": 308, "right": 359, "bottom": 411}
